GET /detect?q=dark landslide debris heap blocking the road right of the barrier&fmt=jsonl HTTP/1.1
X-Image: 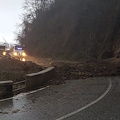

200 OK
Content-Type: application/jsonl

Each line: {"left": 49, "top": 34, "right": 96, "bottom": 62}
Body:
{"left": 44, "top": 59, "right": 120, "bottom": 84}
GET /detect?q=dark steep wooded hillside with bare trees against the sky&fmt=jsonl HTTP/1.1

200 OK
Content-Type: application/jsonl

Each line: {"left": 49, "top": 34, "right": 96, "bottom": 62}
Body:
{"left": 18, "top": 0, "right": 120, "bottom": 59}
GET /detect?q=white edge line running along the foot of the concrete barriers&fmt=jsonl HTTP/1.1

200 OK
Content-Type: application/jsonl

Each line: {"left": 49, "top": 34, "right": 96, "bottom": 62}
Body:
{"left": 0, "top": 86, "right": 49, "bottom": 102}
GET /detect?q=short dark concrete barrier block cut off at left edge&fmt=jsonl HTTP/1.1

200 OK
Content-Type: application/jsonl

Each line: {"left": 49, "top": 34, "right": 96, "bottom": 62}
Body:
{"left": 0, "top": 81, "right": 13, "bottom": 99}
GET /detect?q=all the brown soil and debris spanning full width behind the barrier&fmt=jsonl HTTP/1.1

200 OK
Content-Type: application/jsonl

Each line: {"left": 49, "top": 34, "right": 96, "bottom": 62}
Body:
{"left": 0, "top": 57, "right": 120, "bottom": 93}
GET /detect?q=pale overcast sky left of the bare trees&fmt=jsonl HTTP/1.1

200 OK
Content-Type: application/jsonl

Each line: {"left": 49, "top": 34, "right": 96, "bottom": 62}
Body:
{"left": 0, "top": 0, "right": 24, "bottom": 42}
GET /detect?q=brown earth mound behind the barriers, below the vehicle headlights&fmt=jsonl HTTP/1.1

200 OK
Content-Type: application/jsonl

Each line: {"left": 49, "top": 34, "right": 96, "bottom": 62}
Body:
{"left": 0, "top": 58, "right": 43, "bottom": 82}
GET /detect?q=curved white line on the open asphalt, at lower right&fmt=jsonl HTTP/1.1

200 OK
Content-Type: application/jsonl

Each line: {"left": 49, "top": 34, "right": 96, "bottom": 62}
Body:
{"left": 56, "top": 80, "right": 112, "bottom": 120}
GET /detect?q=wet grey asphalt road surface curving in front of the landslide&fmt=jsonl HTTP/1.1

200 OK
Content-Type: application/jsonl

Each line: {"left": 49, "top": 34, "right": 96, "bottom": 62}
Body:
{"left": 0, "top": 77, "right": 120, "bottom": 120}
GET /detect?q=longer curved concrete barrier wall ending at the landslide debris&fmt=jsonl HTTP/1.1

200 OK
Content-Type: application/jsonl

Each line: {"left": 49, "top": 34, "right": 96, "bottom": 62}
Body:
{"left": 26, "top": 67, "right": 55, "bottom": 91}
